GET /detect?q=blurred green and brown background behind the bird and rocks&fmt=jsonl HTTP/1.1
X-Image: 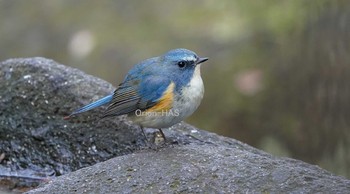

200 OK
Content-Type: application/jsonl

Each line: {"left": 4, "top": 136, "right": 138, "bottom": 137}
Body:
{"left": 0, "top": 0, "right": 350, "bottom": 178}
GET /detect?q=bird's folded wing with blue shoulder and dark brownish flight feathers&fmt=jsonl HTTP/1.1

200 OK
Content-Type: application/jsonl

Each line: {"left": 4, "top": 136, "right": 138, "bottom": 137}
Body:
{"left": 103, "top": 75, "right": 173, "bottom": 117}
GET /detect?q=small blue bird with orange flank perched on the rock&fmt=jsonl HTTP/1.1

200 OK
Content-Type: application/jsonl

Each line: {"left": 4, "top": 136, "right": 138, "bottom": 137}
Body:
{"left": 66, "top": 49, "right": 208, "bottom": 140}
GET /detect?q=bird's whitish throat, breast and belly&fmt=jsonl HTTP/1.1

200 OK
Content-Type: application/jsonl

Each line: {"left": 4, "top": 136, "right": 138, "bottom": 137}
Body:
{"left": 129, "top": 65, "right": 204, "bottom": 128}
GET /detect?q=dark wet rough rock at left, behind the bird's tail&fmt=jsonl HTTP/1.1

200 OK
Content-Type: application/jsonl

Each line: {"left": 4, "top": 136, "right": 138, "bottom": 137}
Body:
{"left": 0, "top": 58, "right": 145, "bottom": 177}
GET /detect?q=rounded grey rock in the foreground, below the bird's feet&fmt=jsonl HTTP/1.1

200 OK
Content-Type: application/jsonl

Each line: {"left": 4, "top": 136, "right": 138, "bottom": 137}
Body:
{"left": 29, "top": 144, "right": 350, "bottom": 193}
